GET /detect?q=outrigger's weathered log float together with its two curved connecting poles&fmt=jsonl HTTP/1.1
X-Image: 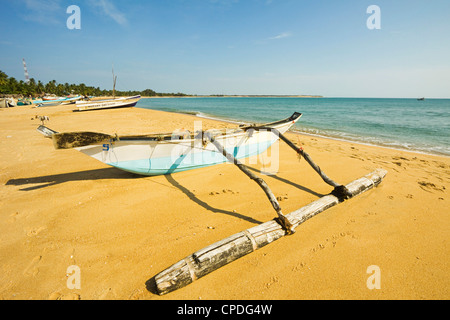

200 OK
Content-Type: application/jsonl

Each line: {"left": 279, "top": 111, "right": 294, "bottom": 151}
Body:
{"left": 154, "top": 126, "right": 387, "bottom": 295}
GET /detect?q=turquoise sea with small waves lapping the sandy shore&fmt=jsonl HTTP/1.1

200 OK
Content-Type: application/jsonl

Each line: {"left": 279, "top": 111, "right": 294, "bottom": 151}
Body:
{"left": 137, "top": 97, "right": 450, "bottom": 156}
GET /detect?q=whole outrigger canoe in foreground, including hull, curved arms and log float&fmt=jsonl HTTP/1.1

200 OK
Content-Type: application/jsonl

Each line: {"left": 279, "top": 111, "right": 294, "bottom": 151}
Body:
{"left": 38, "top": 112, "right": 387, "bottom": 295}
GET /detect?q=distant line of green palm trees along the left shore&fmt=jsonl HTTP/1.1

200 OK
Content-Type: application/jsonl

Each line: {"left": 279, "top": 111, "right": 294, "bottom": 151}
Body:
{"left": 0, "top": 70, "right": 187, "bottom": 97}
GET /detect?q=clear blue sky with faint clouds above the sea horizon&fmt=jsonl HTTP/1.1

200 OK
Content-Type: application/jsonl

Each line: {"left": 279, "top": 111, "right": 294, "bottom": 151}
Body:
{"left": 0, "top": 0, "right": 450, "bottom": 98}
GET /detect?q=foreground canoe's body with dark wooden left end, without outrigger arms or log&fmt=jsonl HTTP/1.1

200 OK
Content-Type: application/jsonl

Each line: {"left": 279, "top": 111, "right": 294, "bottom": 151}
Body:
{"left": 38, "top": 112, "right": 302, "bottom": 176}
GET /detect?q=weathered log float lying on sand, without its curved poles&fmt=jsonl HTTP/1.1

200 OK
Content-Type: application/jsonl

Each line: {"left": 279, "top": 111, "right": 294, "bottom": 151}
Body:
{"left": 155, "top": 169, "right": 387, "bottom": 295}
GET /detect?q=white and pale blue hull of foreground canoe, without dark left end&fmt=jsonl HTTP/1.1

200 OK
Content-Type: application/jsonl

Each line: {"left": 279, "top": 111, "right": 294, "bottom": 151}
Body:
{"left": 76, "top": 116, "right": 300, "bottom": 176}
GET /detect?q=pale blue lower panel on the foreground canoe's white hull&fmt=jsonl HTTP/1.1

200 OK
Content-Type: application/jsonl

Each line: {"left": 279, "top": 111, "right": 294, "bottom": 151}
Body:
{"left": 107, "top": 141, "right": 273, "bottom": 176}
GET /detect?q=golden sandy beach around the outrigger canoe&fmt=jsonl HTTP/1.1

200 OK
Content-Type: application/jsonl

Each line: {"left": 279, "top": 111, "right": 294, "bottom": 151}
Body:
{"left": 0, "top": 106, "right": 450, "bottom": 300}
